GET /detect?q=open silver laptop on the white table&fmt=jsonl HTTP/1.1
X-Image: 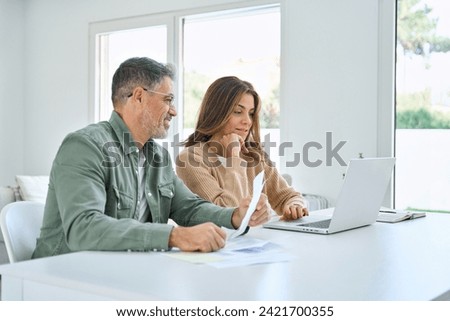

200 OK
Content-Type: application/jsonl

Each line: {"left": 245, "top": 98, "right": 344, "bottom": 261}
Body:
{"left": 263, "top": 157, "right": 395, "bottom": 234}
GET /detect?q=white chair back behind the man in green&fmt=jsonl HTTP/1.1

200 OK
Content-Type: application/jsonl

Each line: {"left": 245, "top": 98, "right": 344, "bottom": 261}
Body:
{"left": 0, "top": 201, "right": 44, "bottom": 263}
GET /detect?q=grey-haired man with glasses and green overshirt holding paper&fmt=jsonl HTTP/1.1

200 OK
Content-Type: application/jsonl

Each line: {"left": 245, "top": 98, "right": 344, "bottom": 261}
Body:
{"left": 33, "top": 58, "right": 268, "bottom": 258}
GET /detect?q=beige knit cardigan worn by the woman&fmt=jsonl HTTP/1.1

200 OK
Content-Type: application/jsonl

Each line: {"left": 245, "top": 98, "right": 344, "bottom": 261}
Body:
{"left": 176, "top": 143, "right": 304, "bottom": 215}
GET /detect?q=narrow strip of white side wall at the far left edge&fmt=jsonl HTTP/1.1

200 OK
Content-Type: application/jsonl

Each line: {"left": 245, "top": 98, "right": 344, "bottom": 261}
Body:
{"left": 0, "top": 0, "right": 26, "bottom": 185}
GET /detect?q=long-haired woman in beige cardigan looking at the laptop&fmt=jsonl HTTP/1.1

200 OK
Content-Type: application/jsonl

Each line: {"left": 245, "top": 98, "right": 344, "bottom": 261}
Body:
{"left": 177, "top": 77, "right": 308, "bottom": 220}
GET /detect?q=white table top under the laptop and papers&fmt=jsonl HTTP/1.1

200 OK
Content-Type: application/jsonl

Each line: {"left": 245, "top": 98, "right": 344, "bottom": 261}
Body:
{"left": 0, "top": 214, "right": 450, "bottom": 301}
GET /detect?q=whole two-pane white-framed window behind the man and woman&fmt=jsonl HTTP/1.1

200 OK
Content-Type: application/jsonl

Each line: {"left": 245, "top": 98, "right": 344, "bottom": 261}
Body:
{"left": 91, "top": 4, "right": 280, "bottom": 164}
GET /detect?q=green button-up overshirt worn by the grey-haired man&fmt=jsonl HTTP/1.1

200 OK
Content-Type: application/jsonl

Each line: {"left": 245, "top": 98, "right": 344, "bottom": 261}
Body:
{"left": 33, "top": 112, "right": 234, "bottom": 258}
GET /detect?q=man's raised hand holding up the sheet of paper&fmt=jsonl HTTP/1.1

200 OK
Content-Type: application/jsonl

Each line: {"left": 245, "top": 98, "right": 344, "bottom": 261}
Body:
{"left": 231, "top": 193, "right": 270, "bottom": 228}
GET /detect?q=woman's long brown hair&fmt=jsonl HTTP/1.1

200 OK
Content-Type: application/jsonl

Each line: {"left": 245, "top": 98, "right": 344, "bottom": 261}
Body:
{"left": 183, "top": 76, "right": 268, "bottom": 164}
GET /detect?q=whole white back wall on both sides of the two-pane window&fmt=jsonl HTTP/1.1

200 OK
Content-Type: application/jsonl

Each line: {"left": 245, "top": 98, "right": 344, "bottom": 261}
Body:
{"left": 0, "top": 0, "right": 394, "bottom": 205}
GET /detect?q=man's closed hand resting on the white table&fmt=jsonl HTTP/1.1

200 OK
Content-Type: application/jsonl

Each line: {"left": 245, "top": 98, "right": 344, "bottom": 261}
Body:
{"left": 169, "top": 223, "right": 226, "bottom": 252}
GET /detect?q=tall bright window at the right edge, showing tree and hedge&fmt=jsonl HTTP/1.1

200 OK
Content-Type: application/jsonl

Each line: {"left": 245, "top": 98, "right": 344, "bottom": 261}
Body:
{"left": 395, "top": 0, "right": 450, "bottom": 212}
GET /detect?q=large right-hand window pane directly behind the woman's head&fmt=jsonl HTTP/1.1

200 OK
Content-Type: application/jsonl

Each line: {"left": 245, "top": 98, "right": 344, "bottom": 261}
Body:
{"left": 181, "top": 6, "right": 280, "bottom": 163}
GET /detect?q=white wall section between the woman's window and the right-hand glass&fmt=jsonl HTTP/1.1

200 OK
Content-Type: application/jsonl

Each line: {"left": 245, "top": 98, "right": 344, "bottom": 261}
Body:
{"left": 281, "top": 0, "right": 394, "bottom": 203}
